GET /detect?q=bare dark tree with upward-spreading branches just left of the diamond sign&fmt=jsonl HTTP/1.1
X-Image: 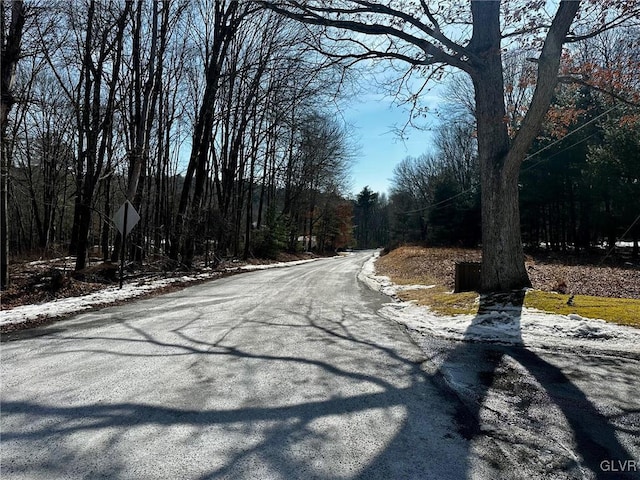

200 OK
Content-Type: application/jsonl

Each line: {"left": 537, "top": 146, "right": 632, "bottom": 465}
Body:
{"left": 30, "top": 0, "right": 132, "bottom": 270}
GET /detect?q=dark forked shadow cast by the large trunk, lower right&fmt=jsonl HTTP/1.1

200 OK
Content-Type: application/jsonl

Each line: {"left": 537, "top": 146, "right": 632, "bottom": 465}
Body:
{"left": 439, "top": 291, "right": 637, "bottom": 479}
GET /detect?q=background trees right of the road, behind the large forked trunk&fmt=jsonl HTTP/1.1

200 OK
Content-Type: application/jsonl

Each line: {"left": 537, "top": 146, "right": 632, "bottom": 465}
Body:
{"left": 356, "top": 28, "right": 640, "bottom": 258}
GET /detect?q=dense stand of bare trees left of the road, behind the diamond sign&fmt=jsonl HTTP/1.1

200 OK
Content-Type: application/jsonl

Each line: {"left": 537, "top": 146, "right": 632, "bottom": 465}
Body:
{"left": 2, "top": 0, "right": 351, "bottom": 288}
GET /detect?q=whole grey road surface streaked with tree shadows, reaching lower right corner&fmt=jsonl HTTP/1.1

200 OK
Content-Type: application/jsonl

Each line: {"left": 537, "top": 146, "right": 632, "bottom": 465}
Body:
{"left": 0, "top": 252, "right": 640, "bottom": 480}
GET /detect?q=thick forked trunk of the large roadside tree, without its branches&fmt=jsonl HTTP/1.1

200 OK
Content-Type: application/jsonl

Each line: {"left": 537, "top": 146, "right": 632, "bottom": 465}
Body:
{"left": 468, "top": 1, "right": 580, "bottom": 291}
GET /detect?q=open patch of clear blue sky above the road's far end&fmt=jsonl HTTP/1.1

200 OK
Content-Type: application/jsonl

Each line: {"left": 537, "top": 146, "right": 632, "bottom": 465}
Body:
{"left": 344, "top": 89, "right": 436, "bottom": 196}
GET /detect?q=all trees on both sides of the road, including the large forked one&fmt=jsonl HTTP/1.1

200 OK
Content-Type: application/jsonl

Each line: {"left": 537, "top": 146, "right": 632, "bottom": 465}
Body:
{"left": 0, "top": 0, "right": 640, "bottom": 289}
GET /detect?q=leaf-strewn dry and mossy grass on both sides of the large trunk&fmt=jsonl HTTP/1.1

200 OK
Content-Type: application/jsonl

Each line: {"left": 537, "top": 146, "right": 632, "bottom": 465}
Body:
{"left": 376, "top": 246, "right": 640, "bottom": 327}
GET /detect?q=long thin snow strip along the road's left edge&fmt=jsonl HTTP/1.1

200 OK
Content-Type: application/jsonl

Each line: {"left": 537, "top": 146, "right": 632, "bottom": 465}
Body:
{"left": 0, "top": 258, "right": 316, "bottom": 325}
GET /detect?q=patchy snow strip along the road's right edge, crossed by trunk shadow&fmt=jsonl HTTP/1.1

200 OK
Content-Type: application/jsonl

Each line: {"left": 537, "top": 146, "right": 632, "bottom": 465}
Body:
{"left": 359, "top": 253, "right": 640, "bottom": 353}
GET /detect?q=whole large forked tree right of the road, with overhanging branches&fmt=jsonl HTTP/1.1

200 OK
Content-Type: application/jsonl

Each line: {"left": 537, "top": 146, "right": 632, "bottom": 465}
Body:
{"left": 262, "top": 0, "right": 640, "bottom": 290}
